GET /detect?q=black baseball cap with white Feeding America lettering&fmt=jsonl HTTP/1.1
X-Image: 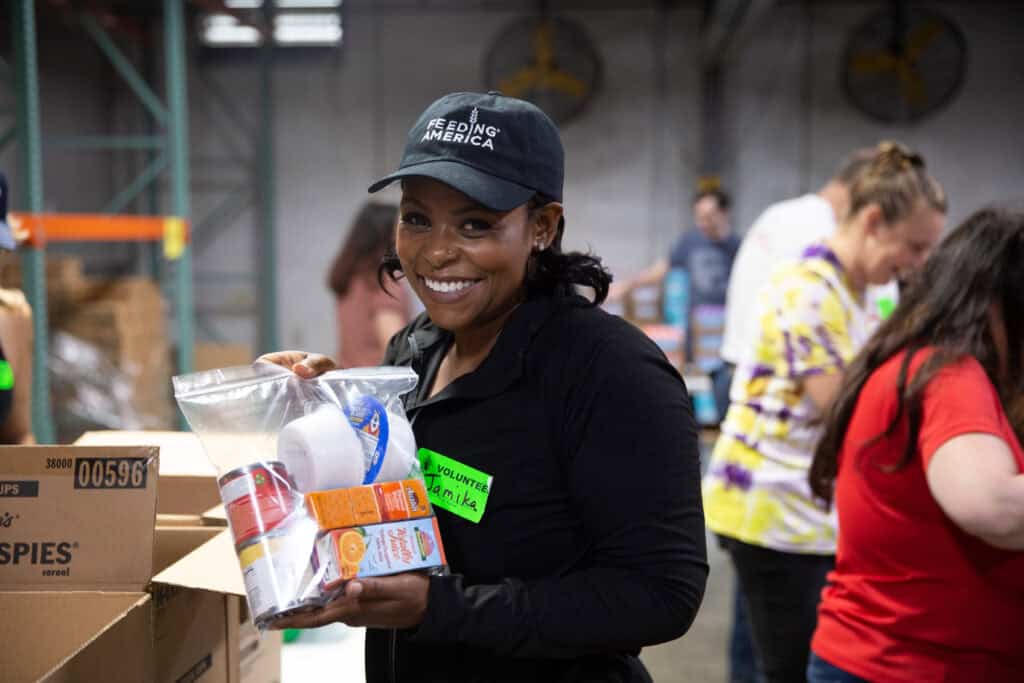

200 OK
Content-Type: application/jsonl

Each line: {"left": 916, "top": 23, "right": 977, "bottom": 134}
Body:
{"left": 369, "top": 91, "right": 565, "bottom": 211}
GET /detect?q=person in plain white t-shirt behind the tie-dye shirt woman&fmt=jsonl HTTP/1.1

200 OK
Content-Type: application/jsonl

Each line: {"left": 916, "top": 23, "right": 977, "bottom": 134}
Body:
{"left": 721, "top": 150, "right": 899, "bottom": 366}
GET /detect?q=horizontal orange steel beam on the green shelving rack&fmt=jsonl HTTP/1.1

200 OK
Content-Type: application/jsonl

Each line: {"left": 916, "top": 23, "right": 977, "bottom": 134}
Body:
{"left": 9, "top": 212, "right": 188, "bottom": 248}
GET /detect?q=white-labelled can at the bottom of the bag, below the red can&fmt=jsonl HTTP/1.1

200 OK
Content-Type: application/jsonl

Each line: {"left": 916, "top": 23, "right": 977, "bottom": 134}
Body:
{"left": 239, "top": 518, "right": 321, "bottom": 627}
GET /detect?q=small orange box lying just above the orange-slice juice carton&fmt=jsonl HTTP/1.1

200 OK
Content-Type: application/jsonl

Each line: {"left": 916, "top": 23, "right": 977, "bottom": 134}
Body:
{"left": 306, "top": 479, "right": 431, "bottom": 531}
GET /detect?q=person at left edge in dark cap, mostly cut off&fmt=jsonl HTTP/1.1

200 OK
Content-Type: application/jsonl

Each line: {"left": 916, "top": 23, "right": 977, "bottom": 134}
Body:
{"left": 0, "top": 173, "right": 36, "bottom": 444}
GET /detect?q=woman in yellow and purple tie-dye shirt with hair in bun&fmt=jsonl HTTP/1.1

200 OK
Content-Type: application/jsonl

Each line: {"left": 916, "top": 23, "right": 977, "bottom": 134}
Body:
{"left": 703, "top": 142, "right": 945, "bottom": 683}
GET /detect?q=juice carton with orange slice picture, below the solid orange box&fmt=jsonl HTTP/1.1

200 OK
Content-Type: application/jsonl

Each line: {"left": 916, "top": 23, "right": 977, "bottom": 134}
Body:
{"left": 313, "top": 517, "right": 447, "bottom": 591}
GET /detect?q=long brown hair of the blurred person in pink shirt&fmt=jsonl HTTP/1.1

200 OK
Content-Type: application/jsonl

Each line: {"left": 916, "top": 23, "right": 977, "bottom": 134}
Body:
{"left": 327, "top": 202, "right": 398, "bottom": 296}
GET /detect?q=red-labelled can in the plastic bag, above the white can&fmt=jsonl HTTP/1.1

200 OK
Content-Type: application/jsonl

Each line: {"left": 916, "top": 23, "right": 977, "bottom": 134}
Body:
{"left": 218, "top": 462, "right": 302, "bottom": 547}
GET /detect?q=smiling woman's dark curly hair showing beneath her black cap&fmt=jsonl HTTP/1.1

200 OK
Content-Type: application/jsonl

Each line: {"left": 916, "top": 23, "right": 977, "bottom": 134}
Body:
{"left": 377, "top": 195, "right": 611, "bottom": 306}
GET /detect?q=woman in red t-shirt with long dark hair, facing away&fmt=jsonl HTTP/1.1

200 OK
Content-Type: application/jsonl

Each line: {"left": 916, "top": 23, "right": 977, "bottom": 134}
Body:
{"left": 808, "top": 210, "right": 1024, "bottom": 683}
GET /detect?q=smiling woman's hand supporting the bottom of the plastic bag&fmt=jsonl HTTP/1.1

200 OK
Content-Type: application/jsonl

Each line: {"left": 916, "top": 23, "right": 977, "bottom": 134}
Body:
{"left": 270, "top": 572, "right": 430, "bottom": 629}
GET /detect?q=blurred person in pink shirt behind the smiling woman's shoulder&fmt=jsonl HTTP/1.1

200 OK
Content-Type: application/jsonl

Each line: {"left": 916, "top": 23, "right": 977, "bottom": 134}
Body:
{"left": 328, "top": 202, "right": 412, "bottom": 368}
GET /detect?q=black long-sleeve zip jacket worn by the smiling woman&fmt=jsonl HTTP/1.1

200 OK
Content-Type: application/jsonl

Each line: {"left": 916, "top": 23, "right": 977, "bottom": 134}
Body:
{"left": 367, "top": 296, "right": 708, "bottom": 683}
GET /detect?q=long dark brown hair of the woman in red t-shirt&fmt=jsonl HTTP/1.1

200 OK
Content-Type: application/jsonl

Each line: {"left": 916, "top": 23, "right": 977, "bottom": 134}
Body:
{"left": 809, "top": 209, "right": 1024, "bottom": 504}
